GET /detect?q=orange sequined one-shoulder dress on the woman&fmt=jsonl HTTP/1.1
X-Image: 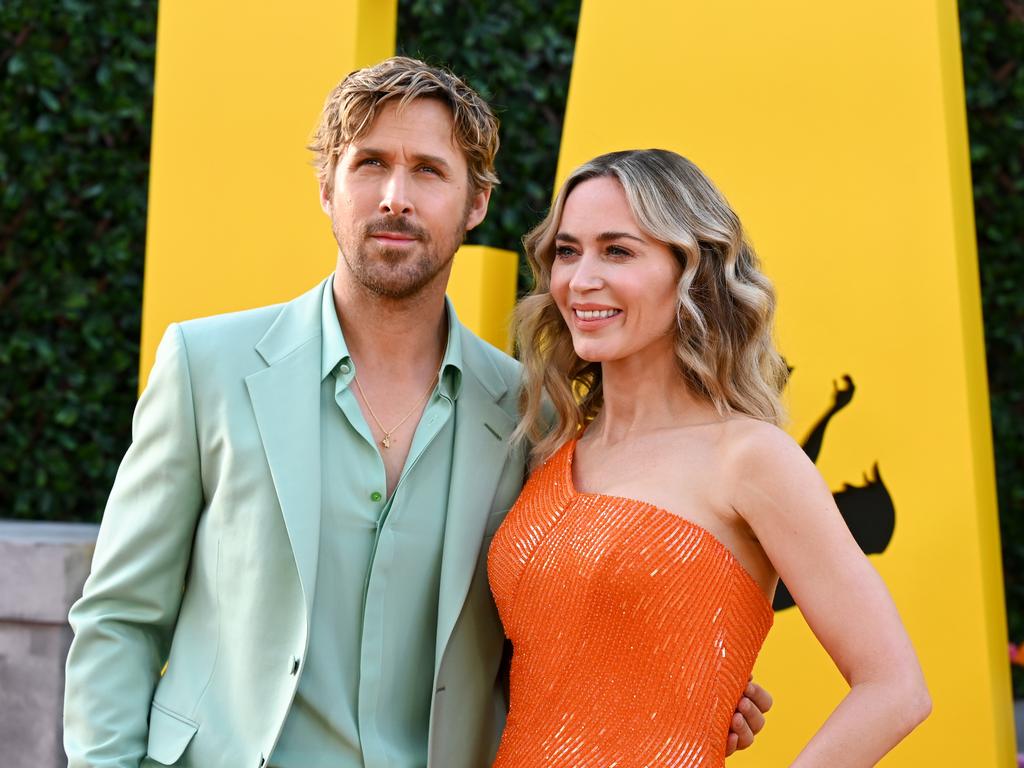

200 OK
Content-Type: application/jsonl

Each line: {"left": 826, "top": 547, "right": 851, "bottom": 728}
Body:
{"left": 487, "top": 440, "right": 772, "bottom": 768}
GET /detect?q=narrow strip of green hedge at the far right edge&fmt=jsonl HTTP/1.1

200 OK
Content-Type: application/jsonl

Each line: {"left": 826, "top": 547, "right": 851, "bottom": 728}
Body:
{"left": 961, "top": 0, "right": 1024, "bottom": 696}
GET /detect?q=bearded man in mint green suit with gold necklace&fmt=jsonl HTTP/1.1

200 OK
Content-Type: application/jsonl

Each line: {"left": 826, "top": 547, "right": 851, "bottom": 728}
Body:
{"left": 65, "top": 57, "right": 767, "bottom": 768}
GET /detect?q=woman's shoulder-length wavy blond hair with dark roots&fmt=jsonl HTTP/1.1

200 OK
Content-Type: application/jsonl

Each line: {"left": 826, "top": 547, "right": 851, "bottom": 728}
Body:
{"left": 514, "top": 150, "right": 787, "bottom": 466}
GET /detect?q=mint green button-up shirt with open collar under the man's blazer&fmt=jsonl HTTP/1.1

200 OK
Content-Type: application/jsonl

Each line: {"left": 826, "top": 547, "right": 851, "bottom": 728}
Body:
{"left": 270, "top": 281, "right": 462, "bottom": 768}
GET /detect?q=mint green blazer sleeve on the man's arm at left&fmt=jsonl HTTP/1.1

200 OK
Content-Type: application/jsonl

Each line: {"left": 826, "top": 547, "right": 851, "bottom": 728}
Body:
{"left": 63, "top": 325, "right": 203, "bottom": 768}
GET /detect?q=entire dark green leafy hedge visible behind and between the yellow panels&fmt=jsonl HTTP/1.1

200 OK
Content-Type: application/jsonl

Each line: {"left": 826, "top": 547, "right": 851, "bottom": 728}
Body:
{"left": 0, "top": 0, "right": 1024, "bottom": 693}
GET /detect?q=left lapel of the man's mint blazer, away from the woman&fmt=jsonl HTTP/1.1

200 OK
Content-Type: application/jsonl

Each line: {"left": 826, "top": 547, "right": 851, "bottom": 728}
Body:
{"left": 246, "top": 283, "right": 325, "bottom": 622}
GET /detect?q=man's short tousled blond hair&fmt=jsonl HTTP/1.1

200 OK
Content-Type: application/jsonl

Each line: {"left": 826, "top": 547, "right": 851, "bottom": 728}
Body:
{"left": 306, "top": 56, "right": 500, "bottom": 195}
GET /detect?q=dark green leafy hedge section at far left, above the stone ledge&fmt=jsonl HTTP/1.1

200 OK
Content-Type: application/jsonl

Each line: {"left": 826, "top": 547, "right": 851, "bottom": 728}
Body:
{"left": 0, "top": 0, "right": 156, "bottom": 520}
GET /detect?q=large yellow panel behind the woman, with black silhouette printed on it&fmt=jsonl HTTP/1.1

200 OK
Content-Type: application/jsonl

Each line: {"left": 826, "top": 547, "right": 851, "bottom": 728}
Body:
{"left": 558, "top": 0, "right": 1013, "bottom": 768}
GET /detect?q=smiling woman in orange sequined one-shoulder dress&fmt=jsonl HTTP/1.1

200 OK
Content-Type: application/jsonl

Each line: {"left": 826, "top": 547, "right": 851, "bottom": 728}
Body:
{"left": 488, "top": 150, "right": 931, "bottom": 768}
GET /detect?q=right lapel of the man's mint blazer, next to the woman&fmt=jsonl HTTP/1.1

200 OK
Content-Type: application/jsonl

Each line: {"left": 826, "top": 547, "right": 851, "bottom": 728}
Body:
{"left": 434, "top": 331, "right": 515, "bottom": 675}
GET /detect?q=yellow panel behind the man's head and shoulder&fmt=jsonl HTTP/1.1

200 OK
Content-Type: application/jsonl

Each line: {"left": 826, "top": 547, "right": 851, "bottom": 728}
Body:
{"left": 140, "top": 0, "right": 516, "bottom": 384}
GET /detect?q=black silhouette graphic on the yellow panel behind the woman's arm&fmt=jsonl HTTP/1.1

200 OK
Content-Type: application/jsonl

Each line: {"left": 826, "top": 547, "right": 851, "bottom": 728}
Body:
{"left": 772, "top": 369, "right": 896, "bottom": 610}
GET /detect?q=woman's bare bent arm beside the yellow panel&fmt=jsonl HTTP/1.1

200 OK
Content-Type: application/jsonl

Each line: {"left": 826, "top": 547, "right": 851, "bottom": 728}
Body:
{"left": 729, "top": 424, "right": 931, "bottom": 768}
